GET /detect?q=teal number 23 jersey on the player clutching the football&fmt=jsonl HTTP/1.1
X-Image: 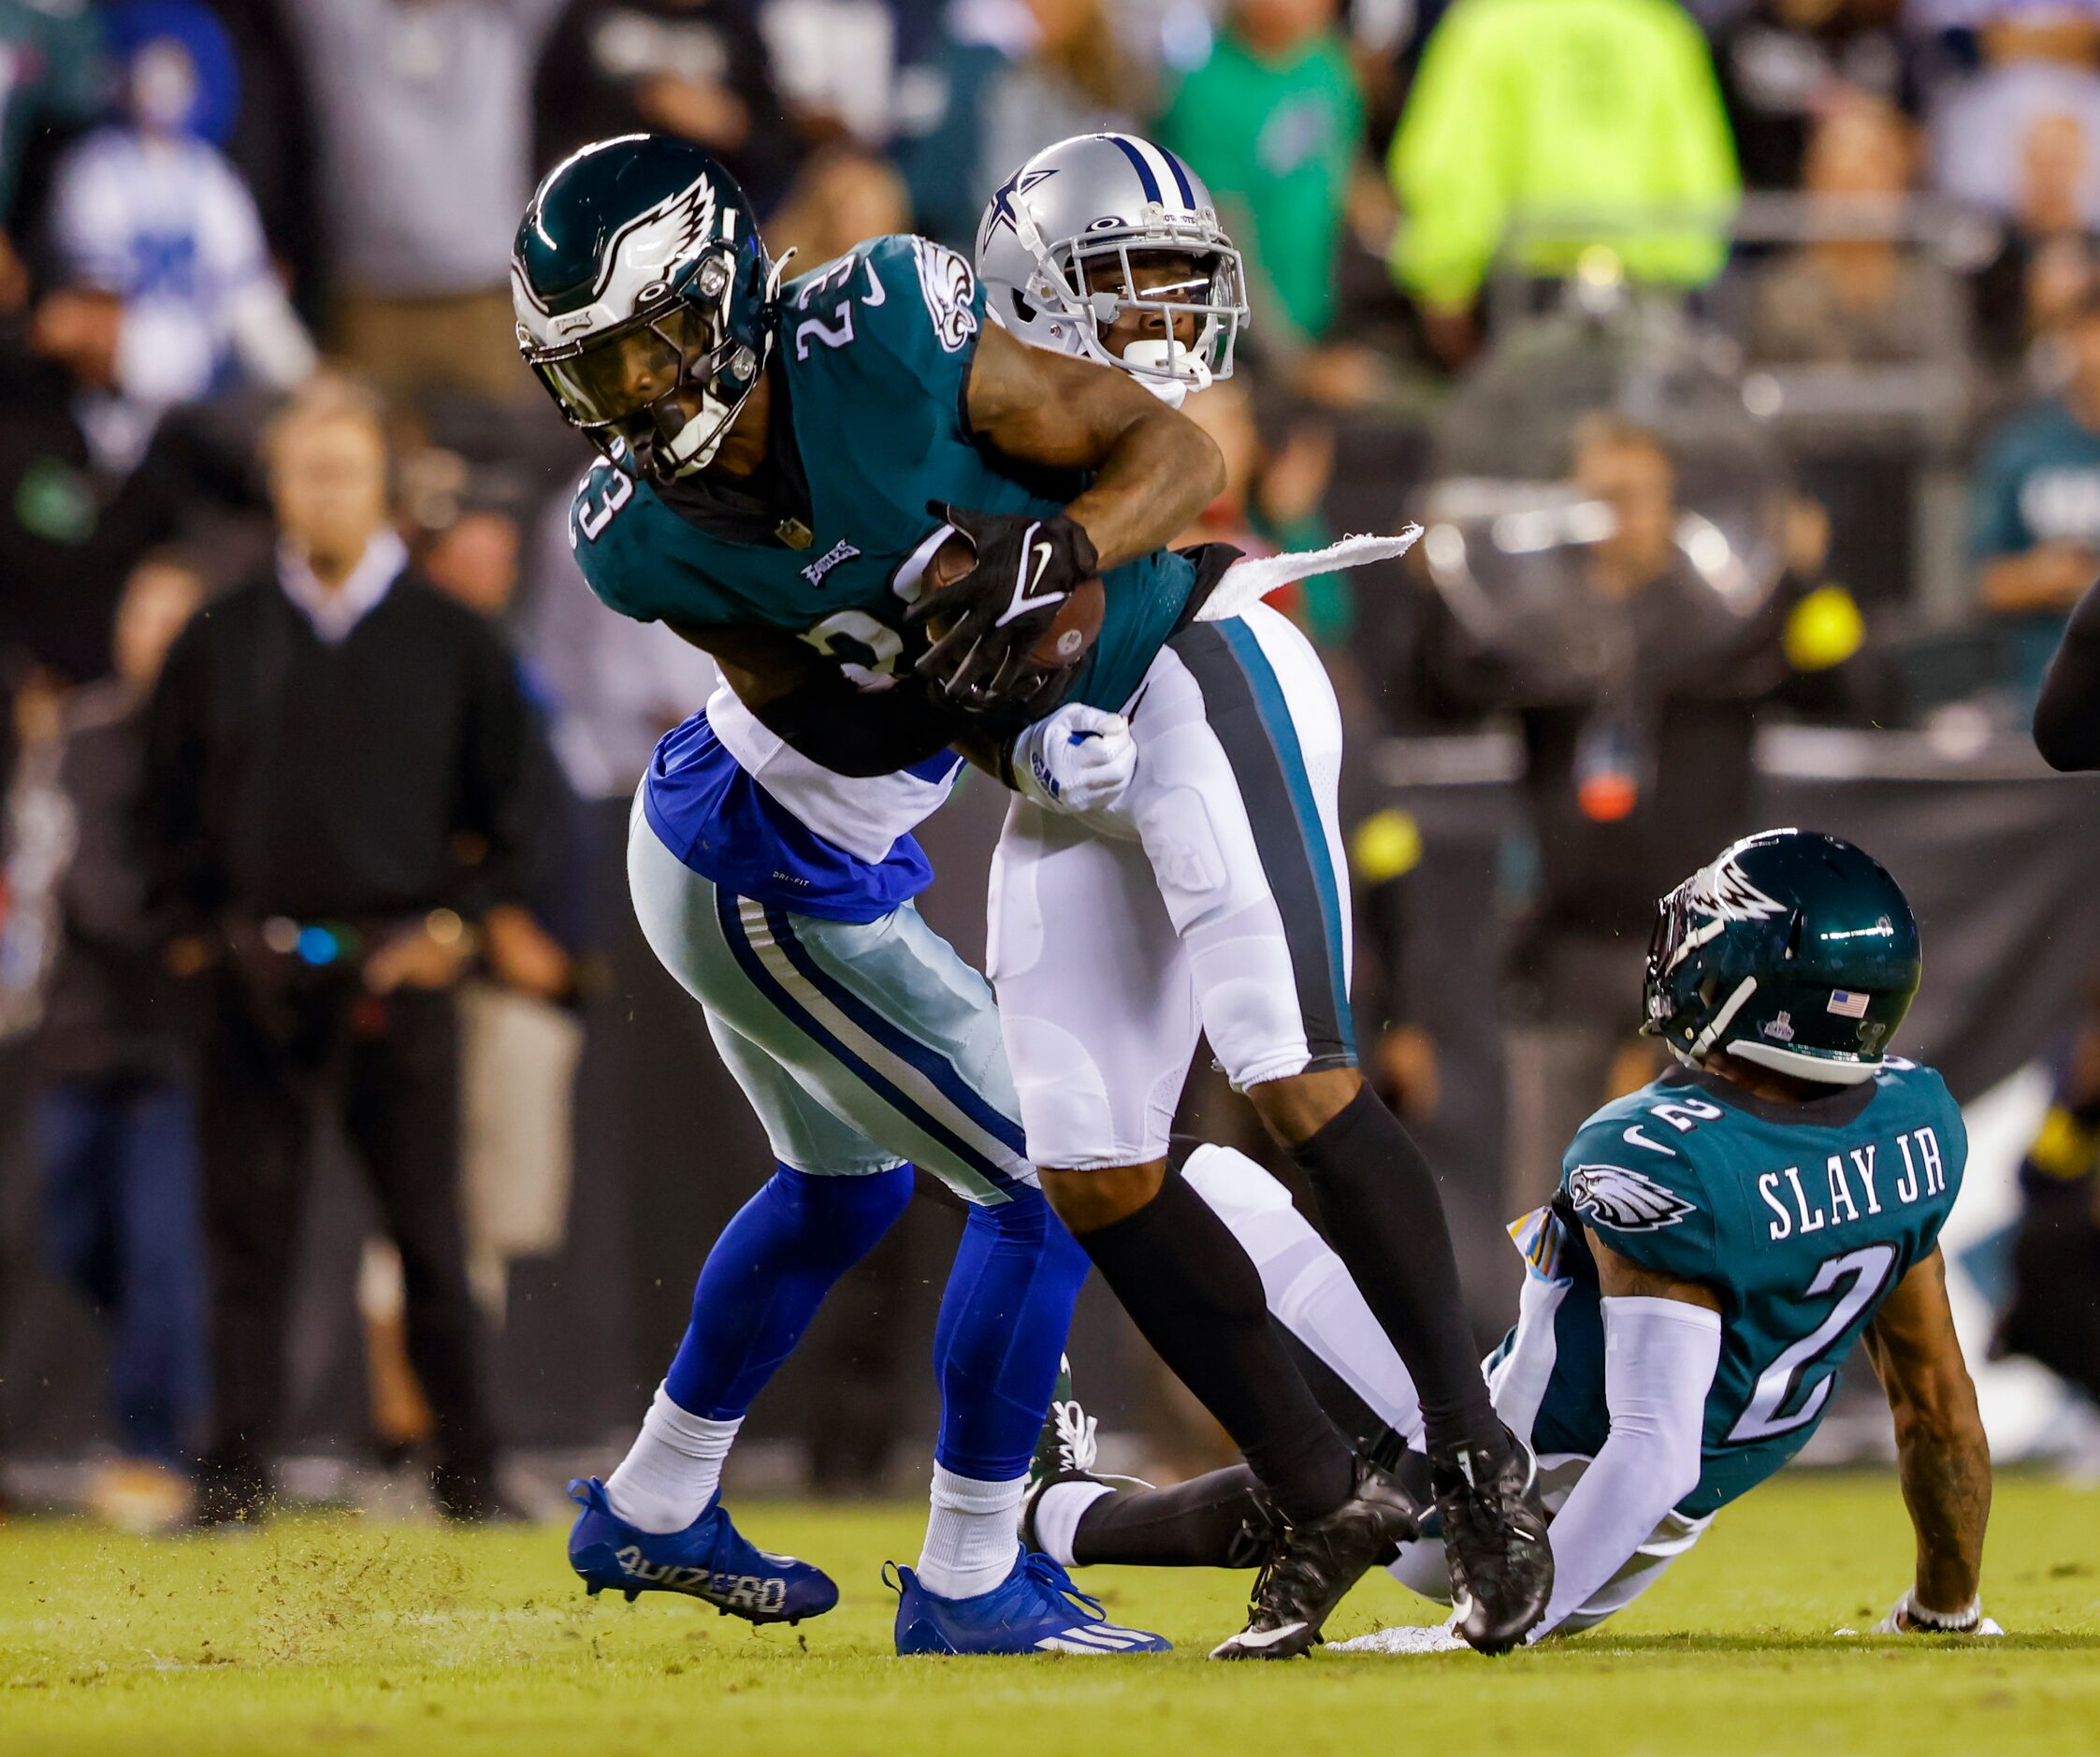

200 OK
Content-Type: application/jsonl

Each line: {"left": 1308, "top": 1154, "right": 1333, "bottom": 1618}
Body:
{"left": 569, "top": 238, "right": 1195, "bottom": 709}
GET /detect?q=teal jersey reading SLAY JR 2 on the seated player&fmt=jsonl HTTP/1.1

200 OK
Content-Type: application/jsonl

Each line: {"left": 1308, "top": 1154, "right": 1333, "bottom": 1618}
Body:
{"left": 1495, "top": 1060, "right": 1968, "bottom": 1517}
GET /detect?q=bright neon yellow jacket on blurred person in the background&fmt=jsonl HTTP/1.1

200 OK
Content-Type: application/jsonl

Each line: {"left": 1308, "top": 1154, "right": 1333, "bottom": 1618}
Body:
{"left": 1388, "top": 0, "right": 1741, "bottom": 356}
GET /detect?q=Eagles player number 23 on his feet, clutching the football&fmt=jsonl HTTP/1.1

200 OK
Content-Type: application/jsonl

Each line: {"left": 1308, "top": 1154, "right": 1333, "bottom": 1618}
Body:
{"left": 513, "top": 137, "right": 1550, "bottom": 1656}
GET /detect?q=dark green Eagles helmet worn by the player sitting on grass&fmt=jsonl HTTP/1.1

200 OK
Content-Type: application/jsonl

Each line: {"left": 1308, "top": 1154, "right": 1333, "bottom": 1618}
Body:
{"left": 1643, "top": 829, "right": 1921, "bottom": 1085}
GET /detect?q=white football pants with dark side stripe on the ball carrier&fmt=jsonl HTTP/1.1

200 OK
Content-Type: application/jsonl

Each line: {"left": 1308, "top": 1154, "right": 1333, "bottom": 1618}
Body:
{"left": 987, "top": 604, "right": 1356, "bottom": 1169}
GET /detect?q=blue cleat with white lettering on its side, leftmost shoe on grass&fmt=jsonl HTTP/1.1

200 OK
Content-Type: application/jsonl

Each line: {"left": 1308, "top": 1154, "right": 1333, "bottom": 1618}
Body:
{"left": 569, "top": 1475, "right": 838, "bottom": 1622}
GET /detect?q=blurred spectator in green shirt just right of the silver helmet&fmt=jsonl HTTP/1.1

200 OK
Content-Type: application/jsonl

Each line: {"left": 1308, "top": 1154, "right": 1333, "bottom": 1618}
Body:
{"left": 1157, "top": 0, "right": 1363, "bottom": 373}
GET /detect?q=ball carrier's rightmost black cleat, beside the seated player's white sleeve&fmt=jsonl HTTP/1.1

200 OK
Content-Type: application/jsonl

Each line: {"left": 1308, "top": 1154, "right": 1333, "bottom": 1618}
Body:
{"left": 1430, "top": 1433, "right": 1554, "bottom": 1654}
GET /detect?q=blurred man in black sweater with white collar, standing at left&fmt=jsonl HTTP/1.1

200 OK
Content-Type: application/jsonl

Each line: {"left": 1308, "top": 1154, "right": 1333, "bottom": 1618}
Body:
{"left": 147, "top": 380, "right": 558, "bottom": 1522}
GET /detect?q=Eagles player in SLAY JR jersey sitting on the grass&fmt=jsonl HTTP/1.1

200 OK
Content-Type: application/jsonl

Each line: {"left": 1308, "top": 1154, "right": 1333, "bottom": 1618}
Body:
{"left": 1022, "top": 829, "right": 1999, "bottom": 1644}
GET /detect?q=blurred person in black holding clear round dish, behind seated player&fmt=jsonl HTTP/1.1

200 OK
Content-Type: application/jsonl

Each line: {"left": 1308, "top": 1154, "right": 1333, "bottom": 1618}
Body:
{"left": 1417, "top": 414, "right": 1874, "bottom": 1207}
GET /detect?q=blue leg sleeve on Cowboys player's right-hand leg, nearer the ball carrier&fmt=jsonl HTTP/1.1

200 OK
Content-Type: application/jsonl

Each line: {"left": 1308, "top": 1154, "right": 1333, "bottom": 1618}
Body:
{"left": 933, "top": 1188, "right": 1088, "bottom": 1482}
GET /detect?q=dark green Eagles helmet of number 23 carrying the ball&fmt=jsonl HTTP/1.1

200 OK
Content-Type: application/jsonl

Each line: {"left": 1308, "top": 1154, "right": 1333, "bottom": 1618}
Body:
{"left": 511, "top": 135, "right": 786, "bottom": 483}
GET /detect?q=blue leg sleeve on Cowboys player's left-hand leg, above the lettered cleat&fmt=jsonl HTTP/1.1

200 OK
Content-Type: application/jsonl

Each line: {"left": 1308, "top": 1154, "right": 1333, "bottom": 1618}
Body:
{"left": 663, "top": 1165, "right": 911, "bottom": 1421}
